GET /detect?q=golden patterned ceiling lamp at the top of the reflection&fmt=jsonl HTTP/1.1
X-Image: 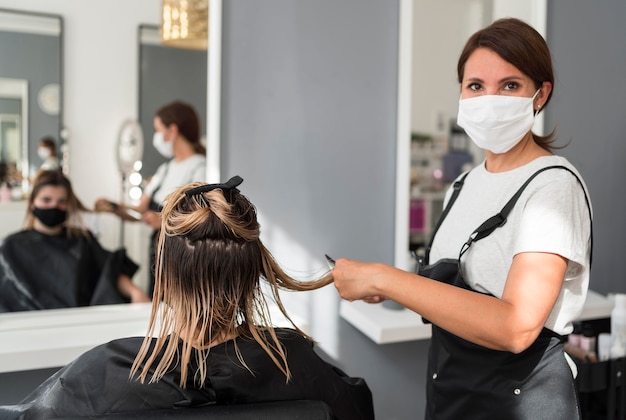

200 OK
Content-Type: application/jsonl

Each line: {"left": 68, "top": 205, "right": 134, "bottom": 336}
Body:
{"left": 161, "top": 0, "right": 209, "bottom": 50}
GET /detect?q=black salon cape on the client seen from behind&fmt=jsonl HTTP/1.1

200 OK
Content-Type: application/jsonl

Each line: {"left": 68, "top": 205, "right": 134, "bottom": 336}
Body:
{"left": 0, "top": 329, "right": 374, "bottom": 420}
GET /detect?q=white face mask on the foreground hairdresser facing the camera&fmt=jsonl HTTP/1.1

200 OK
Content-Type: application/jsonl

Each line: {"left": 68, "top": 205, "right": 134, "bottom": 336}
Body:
{"left": 457, "top": 90, "right": 539, "bottom": 154}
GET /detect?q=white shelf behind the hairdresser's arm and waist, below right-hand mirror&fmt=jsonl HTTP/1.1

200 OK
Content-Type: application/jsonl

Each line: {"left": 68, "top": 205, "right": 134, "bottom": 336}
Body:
{"left": 339, "top": 290, "right": 613, "bottom": 344}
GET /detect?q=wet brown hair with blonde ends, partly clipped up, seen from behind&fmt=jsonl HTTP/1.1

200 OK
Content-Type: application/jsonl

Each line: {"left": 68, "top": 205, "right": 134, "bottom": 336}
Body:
{"left": 130, "top": 182, "right": 332, "bottom": 387}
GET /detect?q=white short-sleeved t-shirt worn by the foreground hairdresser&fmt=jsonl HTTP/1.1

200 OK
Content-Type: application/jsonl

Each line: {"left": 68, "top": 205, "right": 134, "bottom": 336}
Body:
{"left": 430, "top": 156, "right": 591, "bottom": 335}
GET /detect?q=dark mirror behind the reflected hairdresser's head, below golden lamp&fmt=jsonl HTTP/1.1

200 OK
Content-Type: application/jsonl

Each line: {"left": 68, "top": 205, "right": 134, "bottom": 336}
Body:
{"left": 137, "top": 25, "right": 207, "bottom": 179}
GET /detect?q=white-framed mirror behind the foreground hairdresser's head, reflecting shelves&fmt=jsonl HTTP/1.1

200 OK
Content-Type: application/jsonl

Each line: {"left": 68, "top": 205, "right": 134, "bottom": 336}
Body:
{"left": 395, "top": 0, "right": 547, "bottom": 270}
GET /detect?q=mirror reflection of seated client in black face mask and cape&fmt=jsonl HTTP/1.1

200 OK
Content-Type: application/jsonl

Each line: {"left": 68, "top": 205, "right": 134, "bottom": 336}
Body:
{"left": 0, "top": 171, "right": 149, "bottom": 312}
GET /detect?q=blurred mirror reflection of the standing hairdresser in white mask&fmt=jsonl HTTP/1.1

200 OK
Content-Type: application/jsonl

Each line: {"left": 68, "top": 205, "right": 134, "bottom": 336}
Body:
{"left": 95, "top": 101, "right": 206, "bottom": 294}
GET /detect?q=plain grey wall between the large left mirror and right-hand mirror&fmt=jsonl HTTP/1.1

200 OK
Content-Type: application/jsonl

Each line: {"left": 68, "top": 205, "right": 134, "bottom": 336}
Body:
{"left": 222, "top": 0, "right": 428, "bottom": 419}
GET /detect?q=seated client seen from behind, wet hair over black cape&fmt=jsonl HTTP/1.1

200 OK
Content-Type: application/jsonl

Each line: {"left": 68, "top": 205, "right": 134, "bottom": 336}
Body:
{"left": 0, "top": 177, "right": 374, "bottom": 420}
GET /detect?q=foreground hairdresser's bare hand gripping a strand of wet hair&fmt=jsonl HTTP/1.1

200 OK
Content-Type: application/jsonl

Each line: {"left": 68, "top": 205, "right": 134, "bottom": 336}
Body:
{"left": 333, "top": 258, "right": 388, "bottom": 303}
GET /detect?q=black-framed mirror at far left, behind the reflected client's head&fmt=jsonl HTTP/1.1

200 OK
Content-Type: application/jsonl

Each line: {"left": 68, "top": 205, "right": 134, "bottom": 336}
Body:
{"left": 0, "top": 9, "right": 67, "bottom": 201}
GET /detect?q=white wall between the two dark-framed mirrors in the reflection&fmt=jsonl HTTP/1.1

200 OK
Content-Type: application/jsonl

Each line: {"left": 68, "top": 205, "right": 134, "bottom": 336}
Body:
{"left": 0, "top": 0, "right": 161, "bottom": 253}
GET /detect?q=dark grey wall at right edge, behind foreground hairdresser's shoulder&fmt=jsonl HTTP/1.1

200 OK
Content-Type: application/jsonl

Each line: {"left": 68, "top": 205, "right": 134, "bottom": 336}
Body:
{"left": 546, "top": 0, "right": 626, "bottom": 293}
